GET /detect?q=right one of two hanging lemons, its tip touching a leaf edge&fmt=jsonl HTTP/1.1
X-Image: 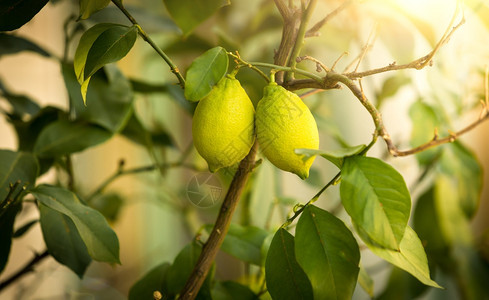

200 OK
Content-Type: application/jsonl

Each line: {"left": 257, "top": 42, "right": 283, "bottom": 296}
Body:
{"left": 255, "top": 82, "right": 319, "bottom": 179}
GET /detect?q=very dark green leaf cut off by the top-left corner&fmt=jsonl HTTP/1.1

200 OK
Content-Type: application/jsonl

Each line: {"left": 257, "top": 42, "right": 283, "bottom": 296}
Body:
{"left": 0, "top": 0, "right": 48, "bottom": 31}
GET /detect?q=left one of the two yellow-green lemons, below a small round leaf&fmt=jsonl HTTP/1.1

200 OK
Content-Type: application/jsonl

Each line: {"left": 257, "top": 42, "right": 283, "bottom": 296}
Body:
{"left": 192, "top": 75, "right": 255, "bottom": 172}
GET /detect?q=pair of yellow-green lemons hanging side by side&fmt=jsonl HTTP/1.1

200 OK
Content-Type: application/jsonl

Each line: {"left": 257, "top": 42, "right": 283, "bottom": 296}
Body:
{"left": 192, "top": 75, "right": 319, "bottom": 179}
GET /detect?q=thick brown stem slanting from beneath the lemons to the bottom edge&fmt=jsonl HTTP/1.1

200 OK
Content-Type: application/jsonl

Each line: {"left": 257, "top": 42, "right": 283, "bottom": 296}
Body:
{"left": 179, "top": 142, "right": 258, "bottom": 300}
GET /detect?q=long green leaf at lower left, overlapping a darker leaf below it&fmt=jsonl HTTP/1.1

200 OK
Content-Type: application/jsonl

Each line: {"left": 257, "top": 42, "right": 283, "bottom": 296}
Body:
{"left": 31, "top": 185, "right": 120, "bottom": 264}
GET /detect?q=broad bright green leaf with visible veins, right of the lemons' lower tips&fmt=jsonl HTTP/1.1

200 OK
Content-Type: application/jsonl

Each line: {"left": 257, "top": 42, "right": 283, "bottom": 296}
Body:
{"left": 340, "top": 156, "right": 411, "bottom": 250}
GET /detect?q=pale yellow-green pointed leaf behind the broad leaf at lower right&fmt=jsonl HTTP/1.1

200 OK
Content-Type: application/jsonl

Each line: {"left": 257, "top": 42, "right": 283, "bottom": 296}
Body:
{"left": 359, "top": 226, "right": 441, "bottom": 288}
